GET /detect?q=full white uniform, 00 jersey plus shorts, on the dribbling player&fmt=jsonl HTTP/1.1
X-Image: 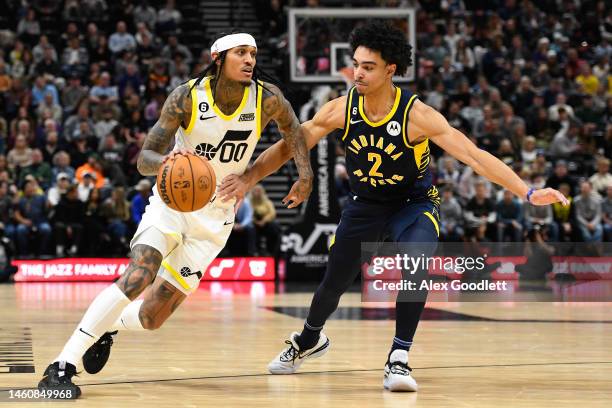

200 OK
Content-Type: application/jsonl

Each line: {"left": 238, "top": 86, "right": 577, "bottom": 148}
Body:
{"left": 130, "top": 78, "right": 262, "bottom": 294}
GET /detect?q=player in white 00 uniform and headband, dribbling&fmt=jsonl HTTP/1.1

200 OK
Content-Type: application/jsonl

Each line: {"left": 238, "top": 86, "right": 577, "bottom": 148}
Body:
{"left": 38, "top": 33, "right": 313, "bottom": 398}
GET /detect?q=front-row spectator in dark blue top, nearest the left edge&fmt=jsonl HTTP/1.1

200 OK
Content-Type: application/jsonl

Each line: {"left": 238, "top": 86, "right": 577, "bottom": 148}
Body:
{"left": 15, "top": 176, "right": 51, "bottom": 256}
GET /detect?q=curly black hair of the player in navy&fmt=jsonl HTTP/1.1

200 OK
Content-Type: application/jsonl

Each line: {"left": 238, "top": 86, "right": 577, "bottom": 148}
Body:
{"left": 349, "top": 20, "right": 412, "bottom": 75}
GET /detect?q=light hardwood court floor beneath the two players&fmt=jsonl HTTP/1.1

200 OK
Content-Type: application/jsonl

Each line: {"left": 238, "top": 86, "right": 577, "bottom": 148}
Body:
{"left": 0, "top": 283, "right": 612, "bottom": 408}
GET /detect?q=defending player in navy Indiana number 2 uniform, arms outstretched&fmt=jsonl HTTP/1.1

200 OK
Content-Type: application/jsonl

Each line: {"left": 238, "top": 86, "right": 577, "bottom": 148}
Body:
{"left": 220, "top": 22, "right": 567, "bottom": 391}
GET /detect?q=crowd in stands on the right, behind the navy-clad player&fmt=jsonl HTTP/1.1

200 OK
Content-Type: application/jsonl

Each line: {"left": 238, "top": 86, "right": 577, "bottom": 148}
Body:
{"left": 266, "top": 0, "right": 612, "bottom": 242}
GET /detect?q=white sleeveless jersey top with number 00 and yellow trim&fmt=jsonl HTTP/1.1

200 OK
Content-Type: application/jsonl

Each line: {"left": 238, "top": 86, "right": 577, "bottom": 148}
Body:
{"left": 174, "top": 77, "right": 262, "bottom": 185}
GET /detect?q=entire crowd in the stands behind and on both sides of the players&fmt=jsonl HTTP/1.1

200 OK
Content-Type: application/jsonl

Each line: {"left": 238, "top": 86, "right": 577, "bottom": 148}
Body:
{"left": 0, "top": 0, "right": 612, "bottom": 262}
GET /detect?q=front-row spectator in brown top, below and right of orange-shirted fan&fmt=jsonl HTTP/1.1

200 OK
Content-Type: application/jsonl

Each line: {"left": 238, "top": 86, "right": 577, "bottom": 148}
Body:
{"left": 101, "top": 187, "right": 130, "bottom": 253}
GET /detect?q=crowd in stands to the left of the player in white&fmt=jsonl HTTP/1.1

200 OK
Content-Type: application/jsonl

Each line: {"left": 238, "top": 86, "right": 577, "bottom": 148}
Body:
{"left": 0, "top": 0, "right": 278, "bottom": 257}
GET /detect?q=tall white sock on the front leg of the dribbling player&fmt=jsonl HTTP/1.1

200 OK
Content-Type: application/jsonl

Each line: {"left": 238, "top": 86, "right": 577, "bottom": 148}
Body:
{"left": 54, "top": 284, "right": 130, "bottom": 367}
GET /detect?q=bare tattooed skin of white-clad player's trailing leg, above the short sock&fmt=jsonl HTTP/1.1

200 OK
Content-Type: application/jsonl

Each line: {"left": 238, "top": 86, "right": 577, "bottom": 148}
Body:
{"left": 138, "top": 277, "right": 187, "bottom": 330}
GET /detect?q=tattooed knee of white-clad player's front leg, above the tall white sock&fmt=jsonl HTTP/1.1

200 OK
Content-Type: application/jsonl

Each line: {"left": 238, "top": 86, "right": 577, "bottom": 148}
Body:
{"left": 117, "top": 245, "right": 162, "bottom": 300}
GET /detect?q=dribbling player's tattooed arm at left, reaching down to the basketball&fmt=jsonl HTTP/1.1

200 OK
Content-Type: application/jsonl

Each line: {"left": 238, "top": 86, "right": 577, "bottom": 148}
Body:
{"left": 136, "top": 84, "right": 191, "bottom": 176}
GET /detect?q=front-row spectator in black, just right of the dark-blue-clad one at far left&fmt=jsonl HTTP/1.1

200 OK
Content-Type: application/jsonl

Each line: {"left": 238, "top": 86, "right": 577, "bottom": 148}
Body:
{"left": 53, "top": 185, "right": 85, "bottom": 257}
